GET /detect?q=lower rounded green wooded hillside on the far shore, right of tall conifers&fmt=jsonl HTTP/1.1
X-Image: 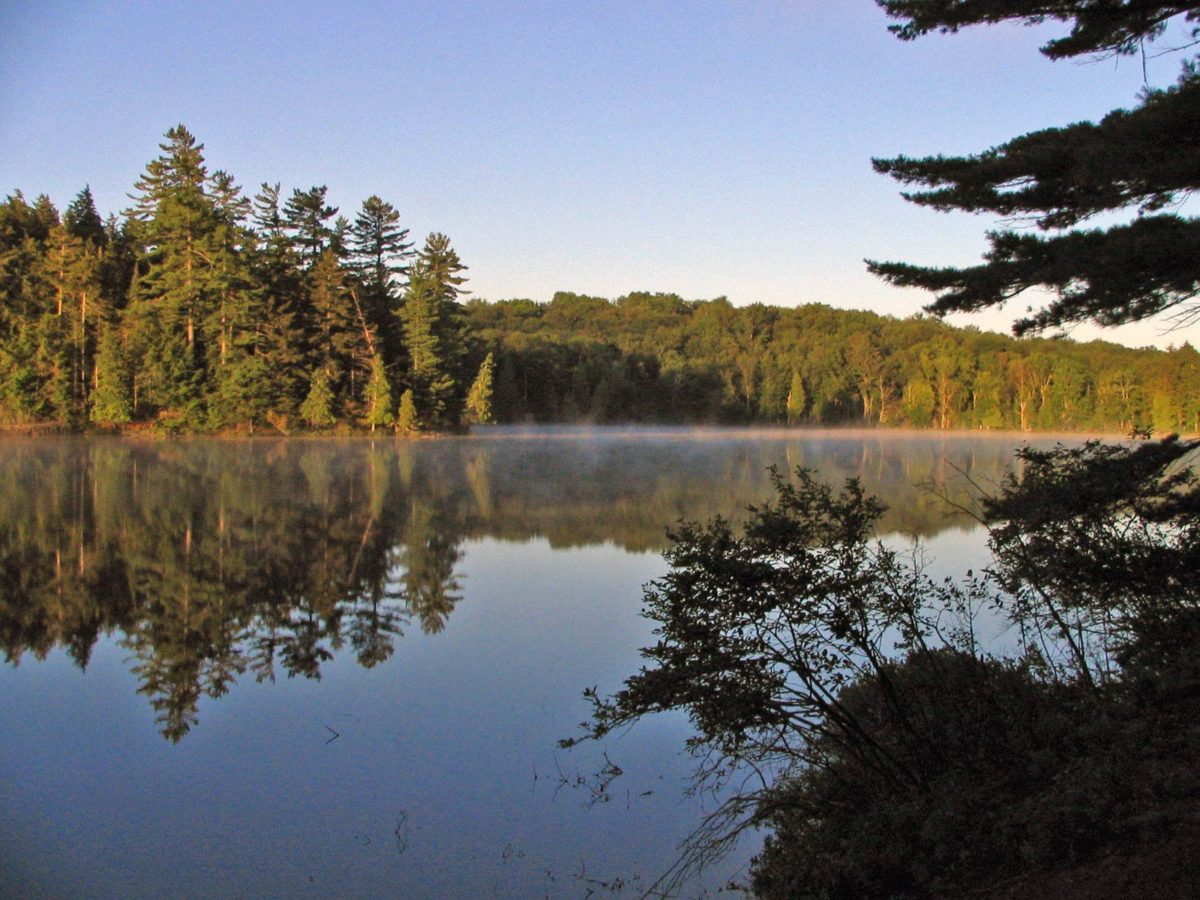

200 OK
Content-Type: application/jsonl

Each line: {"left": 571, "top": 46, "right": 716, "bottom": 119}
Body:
{"left": 467, "top": 293, "right": 1200, "bottom": 432}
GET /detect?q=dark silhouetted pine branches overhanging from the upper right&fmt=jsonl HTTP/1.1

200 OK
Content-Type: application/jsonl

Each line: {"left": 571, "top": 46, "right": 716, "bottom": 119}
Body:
{"left": 869, "top": 0, "right": 1200, "bottom": 334}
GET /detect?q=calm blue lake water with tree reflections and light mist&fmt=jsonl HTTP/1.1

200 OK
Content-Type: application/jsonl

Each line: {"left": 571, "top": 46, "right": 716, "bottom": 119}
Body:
{"left": 0, "top": 428, "right": 1070, "bottom": 898}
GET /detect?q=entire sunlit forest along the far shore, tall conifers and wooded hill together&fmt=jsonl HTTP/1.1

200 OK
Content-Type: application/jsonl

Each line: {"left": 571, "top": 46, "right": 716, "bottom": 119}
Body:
{"left": 0, "top": 125, "right": 1200, "bottom": 433}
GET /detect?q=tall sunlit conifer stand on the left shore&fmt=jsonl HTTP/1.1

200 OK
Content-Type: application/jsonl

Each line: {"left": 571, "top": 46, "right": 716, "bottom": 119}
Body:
{"left": 0, "top": 126, "right": 492, "bottom": 431}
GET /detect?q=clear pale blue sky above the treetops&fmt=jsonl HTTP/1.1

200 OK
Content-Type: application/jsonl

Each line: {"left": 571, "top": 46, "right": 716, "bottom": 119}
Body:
{"left": 0, "top": 0, "right": 1200, "bottom": 346}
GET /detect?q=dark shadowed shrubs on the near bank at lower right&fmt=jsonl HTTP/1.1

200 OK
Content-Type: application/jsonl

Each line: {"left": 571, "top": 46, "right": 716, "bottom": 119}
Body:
{"left": 564, "top": 439, "right": 1200, "bottom": 899}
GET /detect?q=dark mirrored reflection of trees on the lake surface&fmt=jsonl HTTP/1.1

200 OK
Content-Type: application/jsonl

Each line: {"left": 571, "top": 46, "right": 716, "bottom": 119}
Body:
{"left": 0, "top": 431, "right": 1051, "bottom": 742}
